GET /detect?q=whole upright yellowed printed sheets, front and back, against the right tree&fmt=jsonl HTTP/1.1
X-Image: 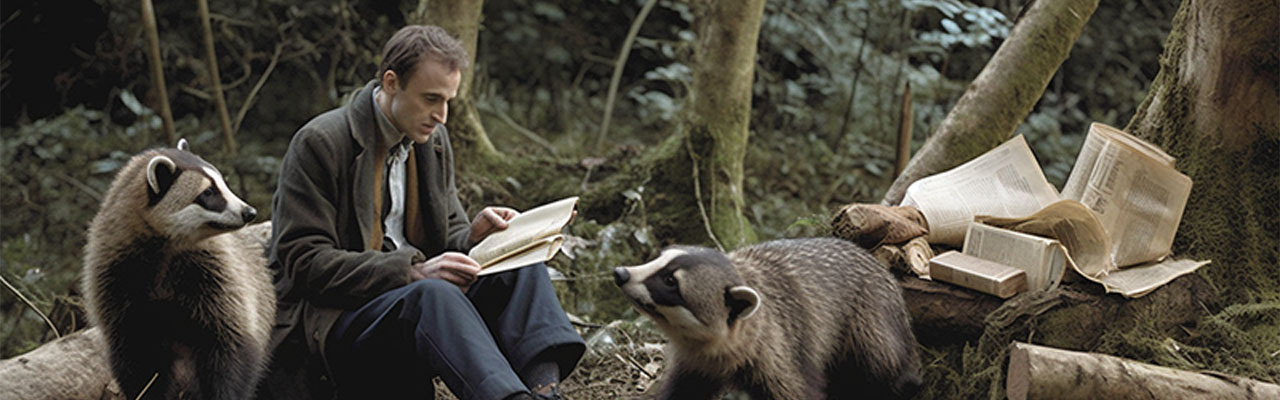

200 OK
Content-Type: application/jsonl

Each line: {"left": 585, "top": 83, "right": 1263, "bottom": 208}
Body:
{"left": 1062, "top": 123, "right": 1192, "bottom": 267}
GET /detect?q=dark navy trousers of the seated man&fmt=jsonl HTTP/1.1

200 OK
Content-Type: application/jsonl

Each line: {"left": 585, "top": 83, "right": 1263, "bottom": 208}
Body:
{"left": 325, "top": 263, "right": 586, "bottom": 399}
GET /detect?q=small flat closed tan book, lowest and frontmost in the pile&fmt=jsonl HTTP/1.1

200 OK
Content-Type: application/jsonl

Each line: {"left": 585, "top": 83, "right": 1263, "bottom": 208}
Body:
{"left": 929, "top": 250, "right": 1027, "bottom": 299}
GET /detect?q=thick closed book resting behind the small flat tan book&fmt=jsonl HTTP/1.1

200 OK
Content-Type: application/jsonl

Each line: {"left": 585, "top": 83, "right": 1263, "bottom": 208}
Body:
{"left": 962, "top": 222, "right": 1068, "bottom": 290}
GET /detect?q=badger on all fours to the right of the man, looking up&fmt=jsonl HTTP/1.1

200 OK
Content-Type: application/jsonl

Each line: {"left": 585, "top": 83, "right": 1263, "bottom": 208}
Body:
{"left": 613, "top": 238, "right": 920, "bottom": 399}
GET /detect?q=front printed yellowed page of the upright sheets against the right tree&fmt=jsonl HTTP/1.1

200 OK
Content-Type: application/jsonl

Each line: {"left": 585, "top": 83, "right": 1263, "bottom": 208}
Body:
{"left": 1080, "top": 141, "right": 1192, "bottom": 268}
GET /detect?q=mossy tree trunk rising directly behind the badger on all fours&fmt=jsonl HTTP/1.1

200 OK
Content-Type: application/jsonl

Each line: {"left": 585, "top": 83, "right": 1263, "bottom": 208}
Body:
{"left": 645, "top": 0, "right": 764, "bottom": 250}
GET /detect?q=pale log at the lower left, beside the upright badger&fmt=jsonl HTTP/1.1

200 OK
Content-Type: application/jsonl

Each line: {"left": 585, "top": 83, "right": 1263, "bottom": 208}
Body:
{"left": 0, "top": 328, "right": 124, "bottom": 400}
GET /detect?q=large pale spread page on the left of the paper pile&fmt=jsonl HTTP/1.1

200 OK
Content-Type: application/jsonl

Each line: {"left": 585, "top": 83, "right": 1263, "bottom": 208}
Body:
{"left": 901, "top": 135, "right": 1059, "bottom": 247}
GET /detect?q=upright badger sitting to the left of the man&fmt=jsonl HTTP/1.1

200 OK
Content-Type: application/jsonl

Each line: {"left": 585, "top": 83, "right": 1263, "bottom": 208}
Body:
{"left": 82, "top": 140, "right": 275, "bottom": 399}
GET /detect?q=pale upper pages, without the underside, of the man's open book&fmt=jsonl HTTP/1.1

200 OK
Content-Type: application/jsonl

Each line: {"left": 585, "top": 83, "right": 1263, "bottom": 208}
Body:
{"left": 467, "top": 196, "right": 577, "bottom": 267}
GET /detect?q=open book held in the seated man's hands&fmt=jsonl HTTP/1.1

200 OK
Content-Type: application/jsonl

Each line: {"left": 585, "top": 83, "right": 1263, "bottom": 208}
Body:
{"left": 467, "top": 196, "right": 577, "bottom": 276}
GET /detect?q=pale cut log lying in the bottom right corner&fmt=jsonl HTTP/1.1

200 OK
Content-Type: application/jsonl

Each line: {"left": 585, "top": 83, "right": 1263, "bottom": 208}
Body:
{"left": 1006, "top": 342, "right": 1280, "bottom": 400}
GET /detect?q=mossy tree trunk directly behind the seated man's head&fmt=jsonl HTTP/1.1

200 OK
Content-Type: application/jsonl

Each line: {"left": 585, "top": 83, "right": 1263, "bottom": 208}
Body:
{"left": 406, "top": 0, "right": 498, "bottom": 163}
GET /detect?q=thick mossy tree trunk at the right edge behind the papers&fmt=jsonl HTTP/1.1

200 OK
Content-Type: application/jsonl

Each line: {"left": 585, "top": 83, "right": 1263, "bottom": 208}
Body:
{"left": 1126, "top": 0, "right": 1280, "bottom": 303}
